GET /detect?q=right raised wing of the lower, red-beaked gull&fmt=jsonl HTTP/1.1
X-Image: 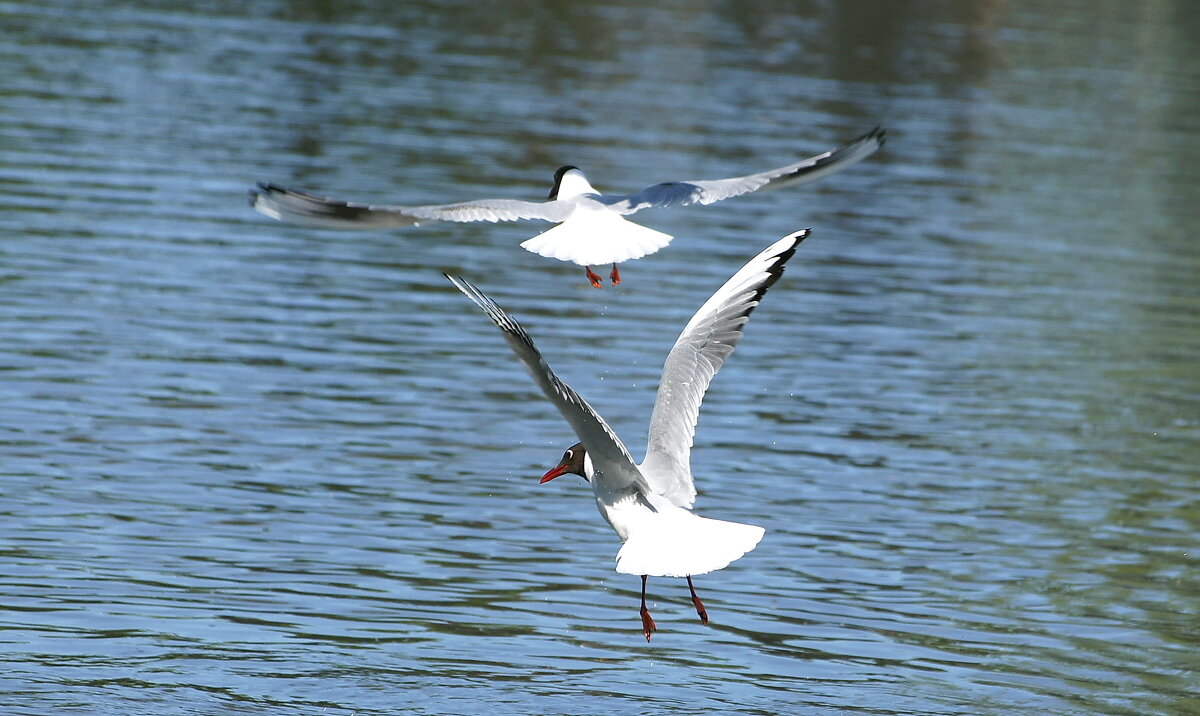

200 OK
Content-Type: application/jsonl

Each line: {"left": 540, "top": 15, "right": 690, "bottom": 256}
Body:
{"left": 641, "top": 229, "right": 809, "bottom": 507}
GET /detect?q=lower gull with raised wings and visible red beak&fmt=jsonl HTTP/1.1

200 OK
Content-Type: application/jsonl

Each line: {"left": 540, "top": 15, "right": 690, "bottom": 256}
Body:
{"left": 446, "top": 229, "right": 809, "bottom": 642}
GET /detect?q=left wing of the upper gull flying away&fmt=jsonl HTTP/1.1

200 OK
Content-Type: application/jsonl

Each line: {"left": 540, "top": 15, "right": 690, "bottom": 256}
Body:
{"left": 250, "top": 183, "right": 570, "bottom": 229}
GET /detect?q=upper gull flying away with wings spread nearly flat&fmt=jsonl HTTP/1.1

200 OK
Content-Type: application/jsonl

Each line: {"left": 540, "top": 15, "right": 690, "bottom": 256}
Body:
{"left": 250, "top": 127, "right": 886, "bottom": 288}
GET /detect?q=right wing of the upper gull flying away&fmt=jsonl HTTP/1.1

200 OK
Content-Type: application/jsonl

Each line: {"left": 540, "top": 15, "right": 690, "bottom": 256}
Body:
{"left": 609, "top": 127, "right": 887, "bottom": 213}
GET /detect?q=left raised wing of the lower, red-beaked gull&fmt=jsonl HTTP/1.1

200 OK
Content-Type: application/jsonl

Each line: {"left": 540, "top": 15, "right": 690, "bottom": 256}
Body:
{"left": 443, "top": 273, "right": 649, "bottom": 493}
